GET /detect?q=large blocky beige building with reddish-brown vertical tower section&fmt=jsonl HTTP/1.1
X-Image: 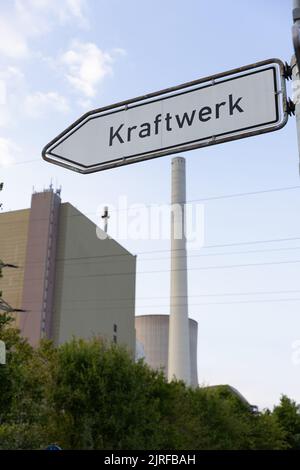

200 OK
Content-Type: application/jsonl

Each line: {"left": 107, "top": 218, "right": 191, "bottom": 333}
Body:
{"left": 0, "top": 189, "right": 136, "bottom": 353}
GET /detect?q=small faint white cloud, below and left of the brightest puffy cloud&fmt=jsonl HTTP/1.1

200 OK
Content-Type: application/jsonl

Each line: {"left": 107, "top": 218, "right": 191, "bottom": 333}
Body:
{"left": 25, "top": 91, "right": 70, "bottom": 118}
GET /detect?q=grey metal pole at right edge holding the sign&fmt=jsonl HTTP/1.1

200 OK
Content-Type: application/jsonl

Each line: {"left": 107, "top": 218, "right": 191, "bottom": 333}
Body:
{"left": 291, "top": 0, "right": 300, "bottom": 173}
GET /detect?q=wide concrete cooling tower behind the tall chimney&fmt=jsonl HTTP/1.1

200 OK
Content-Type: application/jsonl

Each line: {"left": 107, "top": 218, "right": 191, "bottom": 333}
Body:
{"left": 135, "top": 315, "right": 198, "bottom": 387}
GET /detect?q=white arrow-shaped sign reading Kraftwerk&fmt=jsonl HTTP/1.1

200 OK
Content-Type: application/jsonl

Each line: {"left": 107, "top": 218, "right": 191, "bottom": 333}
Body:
{"left": 43, "top": 59, "right": 287, "bottom": 173}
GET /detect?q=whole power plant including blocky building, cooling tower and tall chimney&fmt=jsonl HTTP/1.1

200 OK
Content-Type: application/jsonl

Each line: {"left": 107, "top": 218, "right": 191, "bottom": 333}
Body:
{"left": 0, "top": 157, "right": 198, "bottom": 387}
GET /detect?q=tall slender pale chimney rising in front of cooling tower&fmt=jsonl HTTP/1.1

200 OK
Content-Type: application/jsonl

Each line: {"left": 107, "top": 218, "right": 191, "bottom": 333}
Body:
{"left": 168, "top": 157, "right": 191, "bottom": 385}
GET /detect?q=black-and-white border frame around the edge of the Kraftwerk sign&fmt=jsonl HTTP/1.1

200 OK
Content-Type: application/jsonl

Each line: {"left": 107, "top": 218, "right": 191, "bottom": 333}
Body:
{"left": 42, "top": 59, "right": 287, "bottom": 173}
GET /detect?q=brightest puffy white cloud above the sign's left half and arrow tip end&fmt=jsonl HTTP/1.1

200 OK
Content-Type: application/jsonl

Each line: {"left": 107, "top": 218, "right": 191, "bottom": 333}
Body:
{"left": 60, "top": 41, "right": 113, "bottom": 98}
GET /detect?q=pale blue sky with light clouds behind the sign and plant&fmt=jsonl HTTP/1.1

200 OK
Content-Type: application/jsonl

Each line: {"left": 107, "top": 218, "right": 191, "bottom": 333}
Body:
{"left": 0, "top": 0, "right": 300, "bottom": 408}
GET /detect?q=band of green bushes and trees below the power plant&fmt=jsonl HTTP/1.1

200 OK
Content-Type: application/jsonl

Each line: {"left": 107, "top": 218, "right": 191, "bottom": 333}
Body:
{"left": 0, "top": 322, "right": 299, "bottom": 450}
